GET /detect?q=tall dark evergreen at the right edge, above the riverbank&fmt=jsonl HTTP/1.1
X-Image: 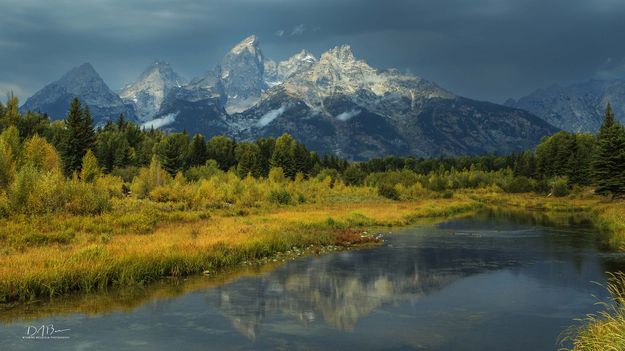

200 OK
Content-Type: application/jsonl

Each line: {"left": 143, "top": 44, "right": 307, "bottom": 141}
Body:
{"left": 593, "top": 104, "right": 625, "bottom": 197}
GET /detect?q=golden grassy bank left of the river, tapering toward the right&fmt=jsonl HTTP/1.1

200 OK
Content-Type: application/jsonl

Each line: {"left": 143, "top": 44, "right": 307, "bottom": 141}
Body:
{"left": 0, "top": 196, "right": 482, "bottom": 302}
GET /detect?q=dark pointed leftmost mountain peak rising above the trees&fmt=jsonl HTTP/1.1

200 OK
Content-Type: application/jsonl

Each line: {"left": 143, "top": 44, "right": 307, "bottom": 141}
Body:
{"left": 20, "top": 63, "right": 135, "bottom": 124}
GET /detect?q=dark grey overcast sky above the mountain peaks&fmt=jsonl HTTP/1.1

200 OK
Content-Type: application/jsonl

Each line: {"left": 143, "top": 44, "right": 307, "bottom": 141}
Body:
{"left": 0, "top": 0, "right": 625, "bottom": 102}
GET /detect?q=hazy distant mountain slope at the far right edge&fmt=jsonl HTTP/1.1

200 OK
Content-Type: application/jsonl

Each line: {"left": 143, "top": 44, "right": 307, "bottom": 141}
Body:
{"left": 505, "top": 80, "right": 625, "bottom": 132}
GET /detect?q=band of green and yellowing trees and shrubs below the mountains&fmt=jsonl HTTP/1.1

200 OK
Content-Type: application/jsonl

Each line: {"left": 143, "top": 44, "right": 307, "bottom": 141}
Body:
{"left": 0, "top": 97, "right": 625, "bottom": 219}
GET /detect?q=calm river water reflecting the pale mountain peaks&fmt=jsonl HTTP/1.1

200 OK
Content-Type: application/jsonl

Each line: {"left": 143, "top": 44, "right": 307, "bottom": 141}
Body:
{"left": 0, "top": 213, "right": 622, "bottom": 351}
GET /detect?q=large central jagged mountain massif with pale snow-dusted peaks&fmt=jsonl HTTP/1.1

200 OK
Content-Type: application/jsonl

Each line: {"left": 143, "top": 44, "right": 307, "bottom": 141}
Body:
{"left": 22, "top": 36, "right": 557, "bottom": 159}
